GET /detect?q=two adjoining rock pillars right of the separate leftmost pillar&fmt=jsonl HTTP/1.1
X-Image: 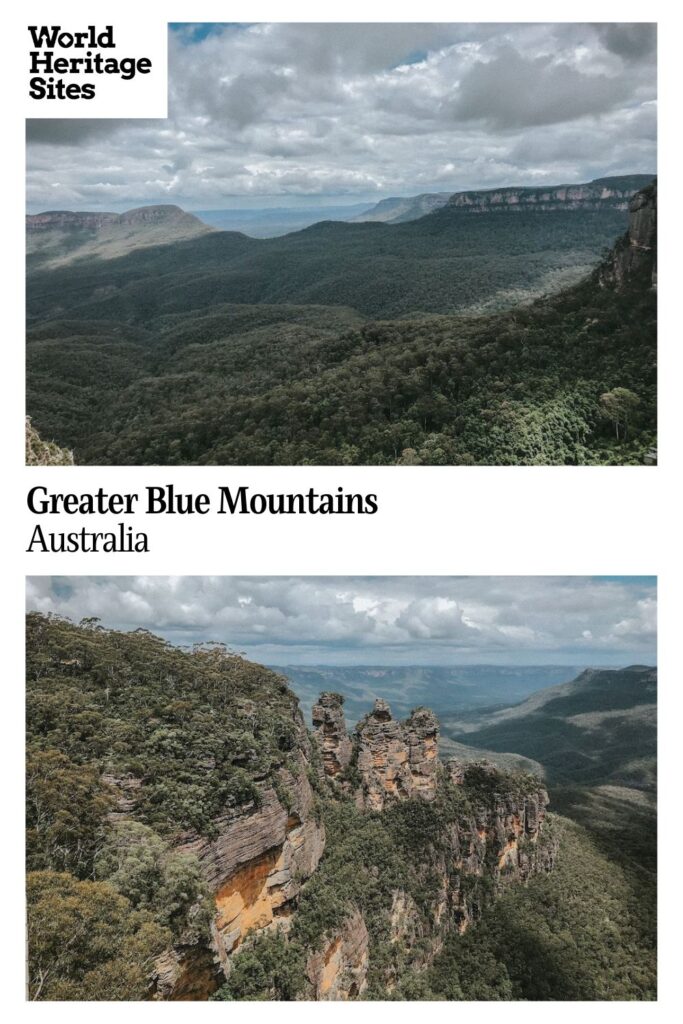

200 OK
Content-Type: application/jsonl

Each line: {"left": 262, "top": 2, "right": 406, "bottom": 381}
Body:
{"left": 356, "top": 698, "right": 438, "bottom": 811}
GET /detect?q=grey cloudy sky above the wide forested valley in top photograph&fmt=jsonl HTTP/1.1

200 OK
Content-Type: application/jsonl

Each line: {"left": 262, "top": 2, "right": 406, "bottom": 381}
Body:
{"left": 27, "top": 24, "right": 656, "bottom": 212}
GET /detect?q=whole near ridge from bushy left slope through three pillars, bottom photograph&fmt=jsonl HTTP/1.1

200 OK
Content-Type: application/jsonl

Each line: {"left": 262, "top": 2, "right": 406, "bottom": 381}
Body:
{"left": 27, "top": 613, "right": 555, "bottom": 999}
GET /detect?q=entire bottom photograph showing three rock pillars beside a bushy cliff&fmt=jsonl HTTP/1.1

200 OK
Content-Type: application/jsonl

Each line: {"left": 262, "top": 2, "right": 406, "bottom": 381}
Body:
{"left": 26, "top": 575, "right": 656, "bottom": 1001}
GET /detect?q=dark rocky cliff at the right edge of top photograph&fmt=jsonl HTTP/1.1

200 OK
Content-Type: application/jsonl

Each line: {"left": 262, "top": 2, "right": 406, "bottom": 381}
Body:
{"left": 598, "top": 180, "right": 657, "bottom": 290}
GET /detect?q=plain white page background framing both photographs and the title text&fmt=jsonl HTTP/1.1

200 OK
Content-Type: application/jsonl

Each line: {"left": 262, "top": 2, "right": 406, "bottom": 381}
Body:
{"left": 0, "top": 0, "right": 683, "bottom": 1021}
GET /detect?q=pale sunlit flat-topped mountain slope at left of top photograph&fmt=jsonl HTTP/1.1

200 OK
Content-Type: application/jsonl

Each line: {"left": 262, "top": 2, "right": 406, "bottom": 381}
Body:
{"left": 26, "top": 205, "right": 212, "bottom": 270}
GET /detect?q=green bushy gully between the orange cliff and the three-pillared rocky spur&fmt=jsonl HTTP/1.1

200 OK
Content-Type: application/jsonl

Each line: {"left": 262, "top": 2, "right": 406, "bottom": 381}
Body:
{"left": 217, "top": 772, "right": 537, "bottom": 999}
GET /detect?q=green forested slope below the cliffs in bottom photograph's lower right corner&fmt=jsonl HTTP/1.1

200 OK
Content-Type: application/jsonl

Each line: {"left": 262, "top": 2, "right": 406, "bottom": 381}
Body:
{"left": 422, "top": 818, "right": 656, "bottom": 1000}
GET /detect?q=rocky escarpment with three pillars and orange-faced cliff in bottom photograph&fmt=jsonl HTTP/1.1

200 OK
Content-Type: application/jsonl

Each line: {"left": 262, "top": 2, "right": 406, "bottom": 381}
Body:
{"left": 157, "top": 693, "right": 555, "bottom": 1000}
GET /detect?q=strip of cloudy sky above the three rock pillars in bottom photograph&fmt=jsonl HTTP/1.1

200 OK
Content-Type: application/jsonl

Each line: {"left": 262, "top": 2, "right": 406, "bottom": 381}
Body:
{"left": 27, "top": 577, "right": 656, "bottom": 666}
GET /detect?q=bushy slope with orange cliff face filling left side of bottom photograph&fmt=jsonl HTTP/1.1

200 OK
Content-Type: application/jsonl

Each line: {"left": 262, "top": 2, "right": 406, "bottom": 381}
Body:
{"left": 27, "top": 614, "right": 325, "bottom": 998}
